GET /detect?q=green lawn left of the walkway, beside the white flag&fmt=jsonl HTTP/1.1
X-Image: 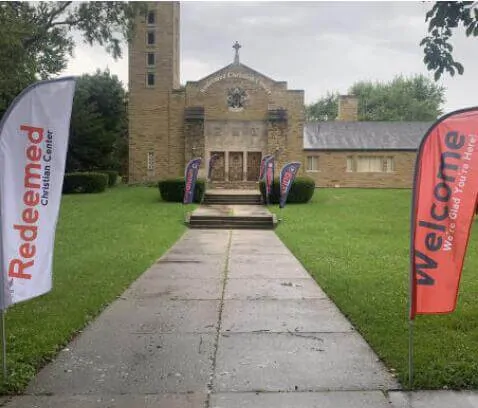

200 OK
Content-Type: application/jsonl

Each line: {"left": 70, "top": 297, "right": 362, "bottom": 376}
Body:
{"left": 1, "top": 186, "right": 189, "bottom": 393}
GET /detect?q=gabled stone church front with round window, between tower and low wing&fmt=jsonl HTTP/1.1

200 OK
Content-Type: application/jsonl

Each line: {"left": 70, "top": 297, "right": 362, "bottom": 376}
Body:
{"left": 185, "top": 62, "right": 304, "bottom": 186}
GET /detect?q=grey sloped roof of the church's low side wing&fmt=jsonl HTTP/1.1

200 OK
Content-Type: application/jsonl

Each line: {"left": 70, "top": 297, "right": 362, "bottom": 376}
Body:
{"left": 304, "top": 122, "right": 433, "bottom": 150}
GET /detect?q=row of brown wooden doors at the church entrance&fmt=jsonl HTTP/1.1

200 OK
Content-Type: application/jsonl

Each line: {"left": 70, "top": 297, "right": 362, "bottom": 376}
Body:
{"left": 211, "top": 152, "right": 262, "bottom": 182}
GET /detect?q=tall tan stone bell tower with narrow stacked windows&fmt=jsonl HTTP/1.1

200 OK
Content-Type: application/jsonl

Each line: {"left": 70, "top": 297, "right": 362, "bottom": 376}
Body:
{"left": 128, "top": 1, "right": 180, "bottom": 183}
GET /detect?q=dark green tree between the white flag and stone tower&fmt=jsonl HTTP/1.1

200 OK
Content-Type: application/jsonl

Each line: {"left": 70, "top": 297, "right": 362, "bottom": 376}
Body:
{"left": 66, "top": 70, "right": 127, "bottom": 172}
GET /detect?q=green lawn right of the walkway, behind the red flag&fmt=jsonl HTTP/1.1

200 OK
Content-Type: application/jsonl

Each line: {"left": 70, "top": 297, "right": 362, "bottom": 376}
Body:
{"left": 274, "top": 189, "right": 478, "bottom": 388}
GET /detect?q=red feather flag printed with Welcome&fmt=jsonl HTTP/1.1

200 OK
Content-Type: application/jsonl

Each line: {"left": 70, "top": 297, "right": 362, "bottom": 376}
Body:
{"left": 410, "top": 108, "right": 478, "bottom": 319}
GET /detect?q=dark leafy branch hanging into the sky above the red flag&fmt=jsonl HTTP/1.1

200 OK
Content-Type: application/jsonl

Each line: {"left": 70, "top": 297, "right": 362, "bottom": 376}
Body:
{"left": 420, "top": 1, "right": 478, "bottom": 81}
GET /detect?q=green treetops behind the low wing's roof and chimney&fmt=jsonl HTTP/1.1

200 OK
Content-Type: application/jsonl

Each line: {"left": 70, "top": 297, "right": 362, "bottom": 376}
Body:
{"left": 306, "top": 75, "right": 444, "bottom": 121}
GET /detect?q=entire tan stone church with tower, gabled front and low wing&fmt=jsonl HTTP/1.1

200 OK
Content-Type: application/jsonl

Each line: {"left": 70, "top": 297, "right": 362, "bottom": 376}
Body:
{"left": 128, "top": 2, "right": 430, "bottom": 188}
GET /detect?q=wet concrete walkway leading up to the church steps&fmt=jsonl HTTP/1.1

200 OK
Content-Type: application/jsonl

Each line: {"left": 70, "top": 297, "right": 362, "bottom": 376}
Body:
{"left": 6, "top": 230, "right": 478, "bottom": 408}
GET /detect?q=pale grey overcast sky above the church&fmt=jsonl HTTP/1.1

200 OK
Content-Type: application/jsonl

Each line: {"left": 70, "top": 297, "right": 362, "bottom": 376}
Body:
{"left": 60, "top": 2, "right": 478, "bottom": 112}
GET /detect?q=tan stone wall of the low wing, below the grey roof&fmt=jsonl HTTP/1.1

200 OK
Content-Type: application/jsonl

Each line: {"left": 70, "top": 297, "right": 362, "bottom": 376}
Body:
{"left": 304, "top": 151, "right": 416, "bottom": 188}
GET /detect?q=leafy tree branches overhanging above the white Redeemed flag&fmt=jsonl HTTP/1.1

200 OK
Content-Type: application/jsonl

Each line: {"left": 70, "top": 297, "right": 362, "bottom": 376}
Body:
{"left": 0, "top": 1, "right": 145, "bottom": 116}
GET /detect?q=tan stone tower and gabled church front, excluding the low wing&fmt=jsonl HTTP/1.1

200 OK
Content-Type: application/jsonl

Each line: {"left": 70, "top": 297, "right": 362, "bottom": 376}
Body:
{"left": 129, "top": 2, "right": 304, "bottom": 187}
